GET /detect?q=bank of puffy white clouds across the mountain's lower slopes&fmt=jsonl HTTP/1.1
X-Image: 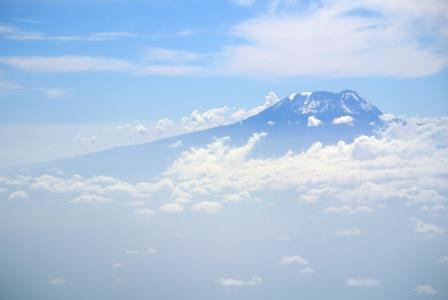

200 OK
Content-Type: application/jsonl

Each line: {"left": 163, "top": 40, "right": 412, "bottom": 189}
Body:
{"left": 11, "top": 118, "right": 448, "bottom": 220}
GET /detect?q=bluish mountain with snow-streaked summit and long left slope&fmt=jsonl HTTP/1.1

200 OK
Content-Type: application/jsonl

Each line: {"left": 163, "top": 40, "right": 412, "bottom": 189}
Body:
{"left": 15, "top": 90, "right": 383, "bottom": 180}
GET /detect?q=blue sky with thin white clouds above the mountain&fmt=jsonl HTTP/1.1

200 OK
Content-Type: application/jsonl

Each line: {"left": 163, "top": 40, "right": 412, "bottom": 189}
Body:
{"left": 0, "top": 0, "right": 448, "bottom": 161}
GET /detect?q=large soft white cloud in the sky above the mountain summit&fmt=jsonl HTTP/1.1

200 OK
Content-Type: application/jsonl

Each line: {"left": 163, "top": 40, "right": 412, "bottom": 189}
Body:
{"left": 221, "top": 0, "right": 448, "bottom": 77}
